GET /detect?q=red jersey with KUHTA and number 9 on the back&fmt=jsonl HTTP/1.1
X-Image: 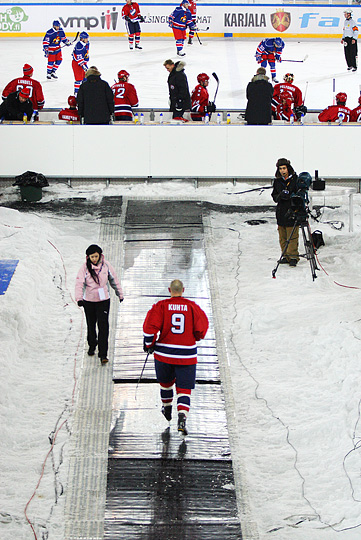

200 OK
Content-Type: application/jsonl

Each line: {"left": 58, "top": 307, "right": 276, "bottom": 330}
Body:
{"left": 143, "top": 296, "right": 208, "bottom": 365}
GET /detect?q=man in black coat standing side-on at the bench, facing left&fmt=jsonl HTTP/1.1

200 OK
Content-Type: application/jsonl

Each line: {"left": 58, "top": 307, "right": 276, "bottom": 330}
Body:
{"left": 163, "top": 60, "right": 191, "bottom": 122}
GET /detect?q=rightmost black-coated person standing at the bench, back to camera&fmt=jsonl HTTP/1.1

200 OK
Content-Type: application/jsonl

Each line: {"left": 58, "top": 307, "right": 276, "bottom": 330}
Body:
{"left": 245, "top": 67, "right": 273, "bottom": 126}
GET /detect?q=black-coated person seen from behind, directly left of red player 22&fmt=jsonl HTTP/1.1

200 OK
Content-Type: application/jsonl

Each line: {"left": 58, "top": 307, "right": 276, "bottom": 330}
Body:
{"left": 77, "top": 66, "right": 114, "bottom": 124}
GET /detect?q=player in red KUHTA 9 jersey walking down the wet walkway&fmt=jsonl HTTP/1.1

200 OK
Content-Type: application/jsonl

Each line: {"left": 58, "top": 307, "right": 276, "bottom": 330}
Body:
{"left": 143, "top": 279, "right": 208, "bottom": 435}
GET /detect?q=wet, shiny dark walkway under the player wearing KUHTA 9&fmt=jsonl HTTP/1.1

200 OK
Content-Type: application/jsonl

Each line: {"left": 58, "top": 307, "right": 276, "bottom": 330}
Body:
{"left": 105, "top": 201, "right": 242, "bottom": 540}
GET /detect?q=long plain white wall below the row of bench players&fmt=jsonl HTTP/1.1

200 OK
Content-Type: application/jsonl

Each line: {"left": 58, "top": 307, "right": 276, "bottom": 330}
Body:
{"left": 0, "top": 124, "right": 361, "bottom": 179}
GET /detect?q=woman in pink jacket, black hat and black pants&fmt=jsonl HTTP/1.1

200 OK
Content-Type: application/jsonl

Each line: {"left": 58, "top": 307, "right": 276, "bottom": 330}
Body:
{"left": 75, "top": 244, "right": 123, "bottom": 364}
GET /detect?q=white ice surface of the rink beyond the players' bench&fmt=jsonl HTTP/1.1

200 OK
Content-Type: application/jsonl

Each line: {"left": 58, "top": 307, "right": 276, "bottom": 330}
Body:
{"left": 0, "top": 33, "right": 361, "bottom": 109}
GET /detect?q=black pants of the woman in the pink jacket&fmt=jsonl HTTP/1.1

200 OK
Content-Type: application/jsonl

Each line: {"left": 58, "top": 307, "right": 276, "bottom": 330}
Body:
{"left": 84, "top": 299, "right": 110, "bottom": 358}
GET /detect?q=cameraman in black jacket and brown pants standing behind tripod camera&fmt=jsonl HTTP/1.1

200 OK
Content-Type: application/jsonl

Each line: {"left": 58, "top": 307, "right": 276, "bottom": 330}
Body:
{"left": 272, "top": 158, "right": 300, "bottom": 266}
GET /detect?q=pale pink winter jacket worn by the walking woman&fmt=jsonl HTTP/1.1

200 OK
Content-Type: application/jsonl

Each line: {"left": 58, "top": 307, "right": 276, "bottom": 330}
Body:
{"left": 75, "top": 255, "right": 123, "bottom": 302}
